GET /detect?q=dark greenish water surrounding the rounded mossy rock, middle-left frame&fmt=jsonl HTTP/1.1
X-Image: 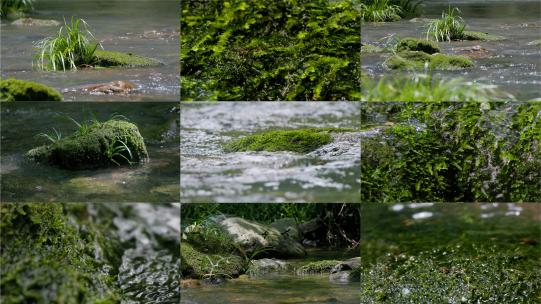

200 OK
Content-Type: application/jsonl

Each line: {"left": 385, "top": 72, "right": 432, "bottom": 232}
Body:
{"left": 1, "top": 103, "right": 180, "bottom": 202}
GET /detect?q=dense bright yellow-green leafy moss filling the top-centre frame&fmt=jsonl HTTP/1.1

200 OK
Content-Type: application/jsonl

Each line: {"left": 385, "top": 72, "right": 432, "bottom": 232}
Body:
{"left": 180, "top": 0, "right": 360, "bottom": 101}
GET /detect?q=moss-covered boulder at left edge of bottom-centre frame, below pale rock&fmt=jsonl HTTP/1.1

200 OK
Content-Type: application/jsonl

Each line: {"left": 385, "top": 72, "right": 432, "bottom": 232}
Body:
{"left": 180, "top": 242, "right": 244, "bottom": 279}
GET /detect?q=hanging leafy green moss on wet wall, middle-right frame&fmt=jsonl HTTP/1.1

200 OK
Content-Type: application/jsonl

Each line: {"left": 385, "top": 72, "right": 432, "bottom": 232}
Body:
{"left": 361, "top": 102, "right": 541, "bottom": 202}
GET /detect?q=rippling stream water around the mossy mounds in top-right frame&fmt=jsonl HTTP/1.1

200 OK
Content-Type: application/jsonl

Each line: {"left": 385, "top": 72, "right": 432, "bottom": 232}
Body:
{"left": 362, "top": 0, "right": 541, "bottom": 100}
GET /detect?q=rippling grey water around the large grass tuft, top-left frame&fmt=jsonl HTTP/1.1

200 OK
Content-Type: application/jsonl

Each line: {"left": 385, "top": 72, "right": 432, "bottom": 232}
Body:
{"left": 1, "top": 0, "right": 180, "bottom": 101}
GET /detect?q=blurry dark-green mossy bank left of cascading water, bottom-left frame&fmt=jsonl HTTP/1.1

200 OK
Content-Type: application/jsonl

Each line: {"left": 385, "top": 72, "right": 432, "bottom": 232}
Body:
{"left": 0, "top": 203, "right": 120, "bottom": 304}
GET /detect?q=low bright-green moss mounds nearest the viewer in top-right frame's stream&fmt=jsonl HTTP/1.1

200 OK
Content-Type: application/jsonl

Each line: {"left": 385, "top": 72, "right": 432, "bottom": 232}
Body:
{"left": 385, "top": 51, "right": 474, "bottom": 70}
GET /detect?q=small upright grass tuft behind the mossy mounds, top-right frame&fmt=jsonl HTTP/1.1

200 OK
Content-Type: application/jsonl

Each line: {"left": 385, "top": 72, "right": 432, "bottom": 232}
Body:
{"left": 426, "top": 6, "right": 466, "bottom": 42}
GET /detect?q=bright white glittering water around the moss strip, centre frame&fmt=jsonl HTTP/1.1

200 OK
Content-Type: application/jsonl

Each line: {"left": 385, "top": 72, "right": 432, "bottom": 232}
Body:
{"left": 181, "top": 102, "right": 360, "bottom": 202}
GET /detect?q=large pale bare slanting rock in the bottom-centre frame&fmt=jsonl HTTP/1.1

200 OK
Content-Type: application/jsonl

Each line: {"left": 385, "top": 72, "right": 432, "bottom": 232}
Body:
{"left": 211, "top": 215, "right": 306, "bottom": 257}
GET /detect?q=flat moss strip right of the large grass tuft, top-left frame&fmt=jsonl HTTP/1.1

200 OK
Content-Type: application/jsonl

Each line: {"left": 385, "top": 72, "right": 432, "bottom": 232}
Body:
{"left": 94, "top": 50, "right": 163, "bottom": 68}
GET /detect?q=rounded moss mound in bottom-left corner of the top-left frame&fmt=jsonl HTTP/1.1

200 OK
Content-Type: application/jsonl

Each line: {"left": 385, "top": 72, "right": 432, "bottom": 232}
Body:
{"left": 0, "top": 78, "right": 63, "bottom": 101}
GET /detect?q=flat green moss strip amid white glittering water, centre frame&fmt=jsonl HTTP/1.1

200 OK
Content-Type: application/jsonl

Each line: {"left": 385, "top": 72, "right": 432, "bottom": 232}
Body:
{"left": 220, "top": 129, "right": 332, "bottom": 153}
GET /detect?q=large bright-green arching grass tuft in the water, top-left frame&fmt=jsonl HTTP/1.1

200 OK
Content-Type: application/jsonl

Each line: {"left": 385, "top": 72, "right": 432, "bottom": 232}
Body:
{"left": 35, "top": 17, "right": 101, "bottom": 71}
